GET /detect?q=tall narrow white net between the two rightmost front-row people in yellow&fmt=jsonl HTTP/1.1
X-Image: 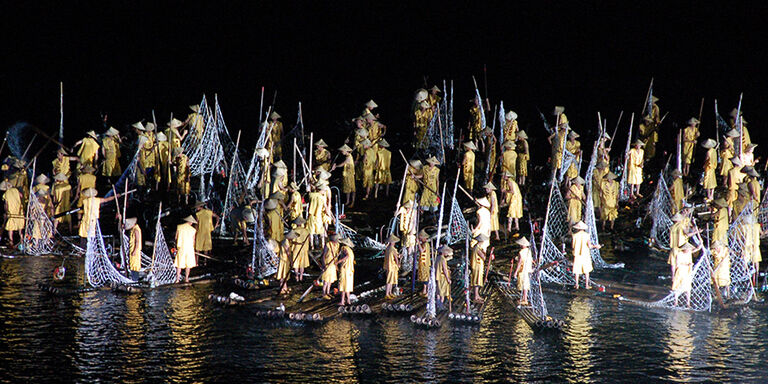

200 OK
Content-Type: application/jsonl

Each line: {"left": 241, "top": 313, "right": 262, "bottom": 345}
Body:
{"left": 728, "top": 202, "right": 755, "bottom": 302}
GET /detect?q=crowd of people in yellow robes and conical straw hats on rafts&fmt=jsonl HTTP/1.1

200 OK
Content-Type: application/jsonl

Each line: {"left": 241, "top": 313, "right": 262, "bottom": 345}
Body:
{"left": 0, "top": 82, "right": 761, "bottom": 310}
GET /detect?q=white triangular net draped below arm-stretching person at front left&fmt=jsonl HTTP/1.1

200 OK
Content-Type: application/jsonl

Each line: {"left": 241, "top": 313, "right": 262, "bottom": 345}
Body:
{"left": 85, "top": 220, "right": 134, "bottom": 287}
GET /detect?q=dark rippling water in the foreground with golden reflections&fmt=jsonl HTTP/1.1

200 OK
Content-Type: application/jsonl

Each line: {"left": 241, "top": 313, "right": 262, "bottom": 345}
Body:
{"left": 0, "top": 250, "right": 768, "bottom": 383}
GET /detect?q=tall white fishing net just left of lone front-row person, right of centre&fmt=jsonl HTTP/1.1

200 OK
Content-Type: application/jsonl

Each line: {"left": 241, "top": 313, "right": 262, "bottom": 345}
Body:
{"left": 539, "top": 184, "right": 576, "bottom": 285}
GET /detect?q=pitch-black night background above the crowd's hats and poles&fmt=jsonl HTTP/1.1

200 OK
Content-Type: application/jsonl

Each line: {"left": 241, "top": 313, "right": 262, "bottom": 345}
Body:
{"left": 0, "top": 1, "right": 768, "bottom": 156}
